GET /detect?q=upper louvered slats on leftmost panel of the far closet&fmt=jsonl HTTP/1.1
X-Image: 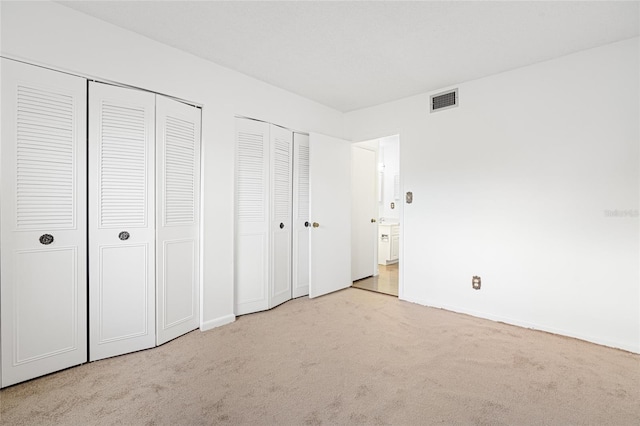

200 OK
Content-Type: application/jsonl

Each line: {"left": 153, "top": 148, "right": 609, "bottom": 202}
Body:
{"left": 236, "top": 132, "right": 265, "bottom": 221}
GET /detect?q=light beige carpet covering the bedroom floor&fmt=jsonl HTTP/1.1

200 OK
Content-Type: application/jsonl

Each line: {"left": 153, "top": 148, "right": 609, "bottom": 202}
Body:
{"left": 0, "top": 289, "right": 640, "bottom": 425}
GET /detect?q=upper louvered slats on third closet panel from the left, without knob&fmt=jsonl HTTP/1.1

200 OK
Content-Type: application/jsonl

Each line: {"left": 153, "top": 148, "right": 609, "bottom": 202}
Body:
{"left": 164, "top": 116, "right": 196, "bottom": 225}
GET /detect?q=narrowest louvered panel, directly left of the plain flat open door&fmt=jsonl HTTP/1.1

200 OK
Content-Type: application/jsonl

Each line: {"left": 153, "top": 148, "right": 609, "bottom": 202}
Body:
{"left": 291, "top": 133, "right": 311, "bottom": 297}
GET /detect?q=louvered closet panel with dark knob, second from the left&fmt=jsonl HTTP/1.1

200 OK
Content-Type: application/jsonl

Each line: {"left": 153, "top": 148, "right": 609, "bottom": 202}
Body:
{"left": 89, "top": 83, "right": 156, "bottom": 361}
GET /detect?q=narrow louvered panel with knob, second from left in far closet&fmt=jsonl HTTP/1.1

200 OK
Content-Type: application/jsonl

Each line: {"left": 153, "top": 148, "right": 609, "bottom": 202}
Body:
{"left": 269, "top": 124, "right": 293, "bottom": 308}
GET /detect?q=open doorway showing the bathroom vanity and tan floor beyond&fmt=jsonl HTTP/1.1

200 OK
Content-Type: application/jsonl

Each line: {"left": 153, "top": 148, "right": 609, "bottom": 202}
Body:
{"left": 351, "top": 135, "right": 401, "bottom": 296}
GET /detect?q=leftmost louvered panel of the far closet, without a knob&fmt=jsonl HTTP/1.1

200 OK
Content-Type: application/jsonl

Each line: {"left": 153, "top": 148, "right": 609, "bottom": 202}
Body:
{"left": 234, "top": 118, "right": 270, "bottom": 315}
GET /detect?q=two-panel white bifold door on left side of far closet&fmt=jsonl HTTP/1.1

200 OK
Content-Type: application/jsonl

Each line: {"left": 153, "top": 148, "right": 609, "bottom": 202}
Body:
{"left": 234, "top": 118, "right": 293, "bottom": 315}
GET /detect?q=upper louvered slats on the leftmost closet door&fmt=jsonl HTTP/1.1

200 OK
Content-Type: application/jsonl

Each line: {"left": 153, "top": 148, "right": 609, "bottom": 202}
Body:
{"left": 16, "top": 85, "right": 76, "bottom": 229}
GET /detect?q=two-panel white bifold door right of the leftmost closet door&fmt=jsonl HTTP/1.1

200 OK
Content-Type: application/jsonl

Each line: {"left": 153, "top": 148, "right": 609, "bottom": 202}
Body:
{"left": 88, "top": 82, "right": 200, "bottom": 361}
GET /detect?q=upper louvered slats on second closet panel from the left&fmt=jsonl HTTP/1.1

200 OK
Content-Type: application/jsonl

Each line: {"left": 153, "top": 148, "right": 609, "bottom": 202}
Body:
{"left": 99, "top": 101, "right": 148, "bottom": 227}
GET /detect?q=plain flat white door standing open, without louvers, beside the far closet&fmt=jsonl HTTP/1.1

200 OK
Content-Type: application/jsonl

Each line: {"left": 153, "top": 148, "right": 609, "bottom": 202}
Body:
{"left": 309, "top": 133, "right": 351, "bottom": 297}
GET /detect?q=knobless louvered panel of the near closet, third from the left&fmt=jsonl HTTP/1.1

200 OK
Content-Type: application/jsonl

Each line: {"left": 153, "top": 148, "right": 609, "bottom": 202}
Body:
{"left": 156, "top": 95, "right": 200, "bottom": 345}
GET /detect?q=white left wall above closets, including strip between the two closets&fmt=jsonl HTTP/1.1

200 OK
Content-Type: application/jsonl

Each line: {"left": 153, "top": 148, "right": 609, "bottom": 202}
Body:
{"left": 0, "top": 1, "right": 343, "bottom": 329}
